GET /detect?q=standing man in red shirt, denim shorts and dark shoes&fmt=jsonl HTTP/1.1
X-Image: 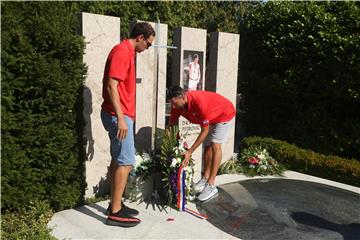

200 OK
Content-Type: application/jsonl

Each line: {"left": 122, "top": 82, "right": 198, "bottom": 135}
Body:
{"left": 101, "top": 22, "right": 155, "bottom": 227}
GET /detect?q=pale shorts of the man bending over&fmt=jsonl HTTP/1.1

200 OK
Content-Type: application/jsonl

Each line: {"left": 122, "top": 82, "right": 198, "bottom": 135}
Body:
{"left": 203, "top": 117, "right": 235, "bottom": 147}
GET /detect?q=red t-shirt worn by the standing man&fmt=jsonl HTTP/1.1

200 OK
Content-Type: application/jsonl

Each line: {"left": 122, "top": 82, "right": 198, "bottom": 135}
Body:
{"left": 101, "top": 40, "right": 136, "bottom": 119}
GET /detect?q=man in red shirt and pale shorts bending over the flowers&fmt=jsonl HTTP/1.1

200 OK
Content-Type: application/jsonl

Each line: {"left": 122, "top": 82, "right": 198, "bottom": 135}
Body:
{"left": 167, "top": 86, "right": 235, "bottom": 201}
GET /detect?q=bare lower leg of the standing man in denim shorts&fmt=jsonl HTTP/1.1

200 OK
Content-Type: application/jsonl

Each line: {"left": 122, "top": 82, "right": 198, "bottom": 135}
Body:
{"left": 111, "top": 166, "right": 132, "bottom": 213}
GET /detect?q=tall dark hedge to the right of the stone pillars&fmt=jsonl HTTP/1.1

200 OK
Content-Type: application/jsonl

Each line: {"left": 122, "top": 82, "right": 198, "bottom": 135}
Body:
{"left": 239, "top": 1, "right": 360, "bottom": 159}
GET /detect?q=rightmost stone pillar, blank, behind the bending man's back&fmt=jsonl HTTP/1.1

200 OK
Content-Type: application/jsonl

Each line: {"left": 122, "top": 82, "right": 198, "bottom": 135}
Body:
{"left": 206, "top": 32, "right": 240, "bottom": 161}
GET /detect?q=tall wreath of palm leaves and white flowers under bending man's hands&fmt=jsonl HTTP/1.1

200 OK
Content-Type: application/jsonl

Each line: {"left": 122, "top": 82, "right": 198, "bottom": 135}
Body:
{"left": 160, "top": 126, "right": 195, "bottom": 204}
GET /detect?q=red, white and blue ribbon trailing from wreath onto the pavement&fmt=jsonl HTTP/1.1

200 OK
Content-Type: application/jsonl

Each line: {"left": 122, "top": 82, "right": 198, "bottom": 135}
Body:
{"left": 177, "top": 165, "right": 208, "bottom": 219}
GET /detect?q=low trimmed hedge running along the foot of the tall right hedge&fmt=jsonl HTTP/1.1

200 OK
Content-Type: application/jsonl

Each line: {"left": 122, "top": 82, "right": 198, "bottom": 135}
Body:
{"left": 241, "top": 137, "right": 360, "bottom": 187}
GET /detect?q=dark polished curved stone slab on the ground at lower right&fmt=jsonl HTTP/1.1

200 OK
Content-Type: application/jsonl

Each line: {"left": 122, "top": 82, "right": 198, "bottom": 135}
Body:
{"left": 197, "top": 179, "right": 360, "bottom": 240}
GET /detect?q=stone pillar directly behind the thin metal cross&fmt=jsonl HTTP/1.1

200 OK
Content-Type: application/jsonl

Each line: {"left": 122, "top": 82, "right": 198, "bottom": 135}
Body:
{"left": 130, "top": 21, "right": 168, "bottom": 151}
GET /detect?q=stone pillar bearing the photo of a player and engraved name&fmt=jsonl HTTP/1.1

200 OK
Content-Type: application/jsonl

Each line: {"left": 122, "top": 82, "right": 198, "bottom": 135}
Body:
{"left": 172, "top": 27, "right": 206, "bottom": 181}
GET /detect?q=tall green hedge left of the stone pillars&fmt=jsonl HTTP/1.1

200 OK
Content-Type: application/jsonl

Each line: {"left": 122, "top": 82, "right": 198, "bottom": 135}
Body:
{"left": 1, "top": 2, "right": 85, "bottom": 210}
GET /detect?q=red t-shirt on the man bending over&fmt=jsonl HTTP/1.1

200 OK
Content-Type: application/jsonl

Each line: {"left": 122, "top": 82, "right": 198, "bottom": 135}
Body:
{"left": 170, "top": 91, "right": 235, "bottom": 127}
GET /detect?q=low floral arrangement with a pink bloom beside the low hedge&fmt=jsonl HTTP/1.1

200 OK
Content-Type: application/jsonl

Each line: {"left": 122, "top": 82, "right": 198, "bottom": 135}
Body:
{"left": 238, "top": 147, "right": 284, "bottom": 176}
